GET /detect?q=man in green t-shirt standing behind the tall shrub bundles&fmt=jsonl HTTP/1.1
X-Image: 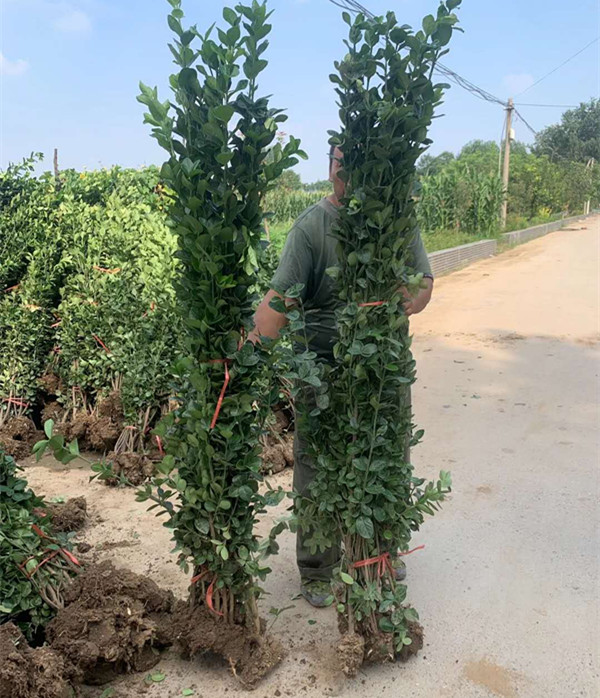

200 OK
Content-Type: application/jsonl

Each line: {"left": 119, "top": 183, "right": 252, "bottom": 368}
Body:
{"left": 250, "top": 146, "right": 433, "bottom": 607}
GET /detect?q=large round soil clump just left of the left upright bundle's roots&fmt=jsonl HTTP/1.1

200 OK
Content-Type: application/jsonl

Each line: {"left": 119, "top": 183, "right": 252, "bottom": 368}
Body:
{"left": 47, "top": 561, "right": 175, "bottom": 684}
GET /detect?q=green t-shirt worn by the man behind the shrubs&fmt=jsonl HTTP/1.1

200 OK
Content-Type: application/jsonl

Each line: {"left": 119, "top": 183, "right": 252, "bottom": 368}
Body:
{"left": 271, "top": 199, "right": 431, "bottom": 360}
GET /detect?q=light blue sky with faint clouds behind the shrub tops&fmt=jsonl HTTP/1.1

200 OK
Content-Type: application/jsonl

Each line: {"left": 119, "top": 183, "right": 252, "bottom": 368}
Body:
{"left": 0, "top": 0, "right": 600, "bottom": 182}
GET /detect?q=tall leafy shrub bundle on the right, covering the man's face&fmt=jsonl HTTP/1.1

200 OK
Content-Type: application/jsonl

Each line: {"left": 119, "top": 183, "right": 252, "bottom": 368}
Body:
{"left": 298, "top": 0, "right": 460, "bottom": 674}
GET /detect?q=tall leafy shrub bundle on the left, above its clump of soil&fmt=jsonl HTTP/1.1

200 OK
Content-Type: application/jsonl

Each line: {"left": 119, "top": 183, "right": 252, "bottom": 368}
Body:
{"left": 139, "top": 0, "right": 303, "bottom": 664}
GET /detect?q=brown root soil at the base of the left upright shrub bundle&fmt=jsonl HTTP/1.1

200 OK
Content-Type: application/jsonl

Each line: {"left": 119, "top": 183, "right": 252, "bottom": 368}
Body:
{"left": 171, "top": 601, "right": 286, "bottom": 688}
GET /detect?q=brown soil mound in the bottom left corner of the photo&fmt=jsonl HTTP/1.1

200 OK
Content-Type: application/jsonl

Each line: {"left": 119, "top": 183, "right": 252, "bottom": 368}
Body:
{"left": 0, "top": 623, "right": 76, "bottom": 698}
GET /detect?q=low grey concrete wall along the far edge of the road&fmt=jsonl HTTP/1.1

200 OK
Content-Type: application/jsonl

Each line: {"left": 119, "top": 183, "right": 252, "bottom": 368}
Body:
{"left": 427, "top": 211, "right": 598, "bottom": 276}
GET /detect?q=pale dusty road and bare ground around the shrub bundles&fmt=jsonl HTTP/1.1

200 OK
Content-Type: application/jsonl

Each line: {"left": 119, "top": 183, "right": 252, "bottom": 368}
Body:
{"left": 28, "top": 217, "right": 600, "bottom": 698}
